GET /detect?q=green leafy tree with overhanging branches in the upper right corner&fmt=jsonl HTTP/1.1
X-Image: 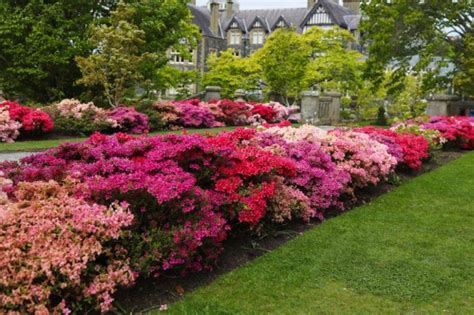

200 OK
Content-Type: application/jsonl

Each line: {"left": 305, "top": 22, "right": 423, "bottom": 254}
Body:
{"left": 362, "top": 0, "right": 474, "bottom": 95}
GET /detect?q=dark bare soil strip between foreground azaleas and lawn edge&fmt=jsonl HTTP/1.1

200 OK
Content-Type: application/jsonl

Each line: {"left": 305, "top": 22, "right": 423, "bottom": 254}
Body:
{"left": 115, "top": 151, "right": 463, "bottom": 314}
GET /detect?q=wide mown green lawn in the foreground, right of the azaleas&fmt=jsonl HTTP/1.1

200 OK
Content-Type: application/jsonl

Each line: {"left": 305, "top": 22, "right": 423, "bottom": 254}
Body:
{"left": 163, "top": 152, "right": 474, "bottom": 314}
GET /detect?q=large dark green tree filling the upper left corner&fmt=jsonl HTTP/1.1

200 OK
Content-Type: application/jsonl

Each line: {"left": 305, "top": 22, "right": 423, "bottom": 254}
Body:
{"left": 0, "top": 0, "right": 113, "bottom": 102}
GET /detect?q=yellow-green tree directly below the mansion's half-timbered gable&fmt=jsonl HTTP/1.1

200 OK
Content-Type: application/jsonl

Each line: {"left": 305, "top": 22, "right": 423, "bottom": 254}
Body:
{"left": 303, "top": 27, "right": 364, "bottom": 94}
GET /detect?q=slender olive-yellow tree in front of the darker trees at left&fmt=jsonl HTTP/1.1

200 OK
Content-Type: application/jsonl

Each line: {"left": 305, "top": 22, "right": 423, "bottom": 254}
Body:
{"left": 76, "top": 2, "right": 155, "bottom": 106}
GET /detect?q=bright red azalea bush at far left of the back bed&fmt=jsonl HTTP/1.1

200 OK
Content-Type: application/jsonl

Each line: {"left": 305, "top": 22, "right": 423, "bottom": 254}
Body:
{"left": 0, "top": 101, "right": 53, "bottom": 140}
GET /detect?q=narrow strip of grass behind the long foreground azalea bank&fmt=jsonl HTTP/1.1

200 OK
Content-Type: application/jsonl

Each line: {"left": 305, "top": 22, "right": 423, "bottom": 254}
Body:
{"left": 0, "top": 127, "right": 239, "bottom": 153}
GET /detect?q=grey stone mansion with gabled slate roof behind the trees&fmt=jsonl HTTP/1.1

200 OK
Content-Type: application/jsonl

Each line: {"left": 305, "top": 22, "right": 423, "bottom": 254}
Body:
{"left": 166, "top": 0, "right": 361, "bottom": 97}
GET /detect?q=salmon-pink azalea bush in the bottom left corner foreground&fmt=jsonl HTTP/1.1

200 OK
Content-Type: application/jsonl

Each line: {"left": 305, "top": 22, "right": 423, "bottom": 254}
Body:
{"left": 0, "top": 181, "right": 135, "bottom": 314}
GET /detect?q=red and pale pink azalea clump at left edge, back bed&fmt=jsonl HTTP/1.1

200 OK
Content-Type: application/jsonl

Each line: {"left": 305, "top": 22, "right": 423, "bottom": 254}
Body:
{"left": 0, "top": 101, "right": 53, "bottom": 142}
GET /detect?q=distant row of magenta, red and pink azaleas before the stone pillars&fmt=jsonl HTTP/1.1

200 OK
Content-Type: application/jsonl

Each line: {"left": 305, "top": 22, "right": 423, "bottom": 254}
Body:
{"left": 153, "top": 100, "right": 297, "bottom": 128}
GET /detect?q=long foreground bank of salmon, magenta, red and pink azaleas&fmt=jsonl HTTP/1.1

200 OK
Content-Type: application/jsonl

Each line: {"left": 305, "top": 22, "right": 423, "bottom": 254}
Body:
{"left": 0, "top": 121, "right": 466, "bottom": 314}
